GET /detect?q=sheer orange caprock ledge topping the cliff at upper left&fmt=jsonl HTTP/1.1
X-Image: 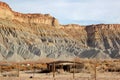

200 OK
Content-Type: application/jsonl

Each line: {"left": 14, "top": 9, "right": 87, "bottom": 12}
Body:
{"left": 0, "top": 2, "right": 59, "bottom": 26}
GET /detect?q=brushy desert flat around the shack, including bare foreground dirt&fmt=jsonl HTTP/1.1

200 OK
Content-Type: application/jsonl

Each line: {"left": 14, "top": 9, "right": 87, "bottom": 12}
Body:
{"left": 0, "top": 60, "right": 120, "bottom": 80}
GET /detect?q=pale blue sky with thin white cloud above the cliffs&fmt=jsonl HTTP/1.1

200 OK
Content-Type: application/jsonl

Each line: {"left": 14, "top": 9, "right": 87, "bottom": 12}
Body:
{"left": 0, "top": 0, "right": 120, "bottom": 25}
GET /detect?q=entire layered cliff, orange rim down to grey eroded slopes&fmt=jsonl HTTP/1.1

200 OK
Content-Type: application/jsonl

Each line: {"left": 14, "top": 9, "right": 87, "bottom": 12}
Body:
{"left": 0, "top": 2, "right": 120, "bottom": 61}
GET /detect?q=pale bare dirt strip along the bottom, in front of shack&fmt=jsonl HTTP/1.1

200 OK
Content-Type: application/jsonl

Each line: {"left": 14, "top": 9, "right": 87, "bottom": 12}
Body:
{"left": 0, "top": 72, "right": 120, "bottom": 80}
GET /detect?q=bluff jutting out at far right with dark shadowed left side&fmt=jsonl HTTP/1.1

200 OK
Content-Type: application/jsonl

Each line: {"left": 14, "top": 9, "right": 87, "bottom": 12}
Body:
{"left": 86, "top": 24, "right": 120, "bottom": 58}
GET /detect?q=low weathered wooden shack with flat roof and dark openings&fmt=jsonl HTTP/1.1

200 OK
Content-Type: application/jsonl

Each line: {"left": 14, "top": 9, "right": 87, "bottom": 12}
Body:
{"left": 47, "top": 61, "right": 84, "bottom": 73}
